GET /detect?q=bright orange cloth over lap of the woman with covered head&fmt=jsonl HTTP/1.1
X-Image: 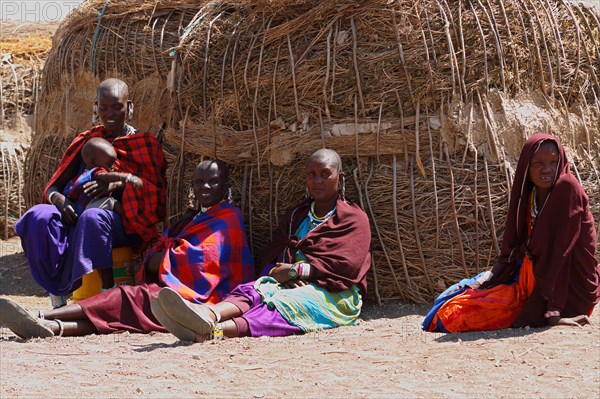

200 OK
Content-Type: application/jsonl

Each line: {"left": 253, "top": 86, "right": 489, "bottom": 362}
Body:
{"left": 431, "top": 257, "right": 535, "bottom": 333}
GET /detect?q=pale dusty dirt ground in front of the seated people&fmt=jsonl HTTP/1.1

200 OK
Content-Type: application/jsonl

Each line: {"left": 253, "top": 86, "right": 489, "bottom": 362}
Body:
{"left": 0, "top": 239, "right": 600, "bottom": 398}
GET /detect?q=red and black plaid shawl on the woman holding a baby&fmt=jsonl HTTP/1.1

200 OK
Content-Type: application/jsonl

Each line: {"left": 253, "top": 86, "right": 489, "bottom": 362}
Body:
{"left": 42, "top": 126, "right": 167, "bottom": 242}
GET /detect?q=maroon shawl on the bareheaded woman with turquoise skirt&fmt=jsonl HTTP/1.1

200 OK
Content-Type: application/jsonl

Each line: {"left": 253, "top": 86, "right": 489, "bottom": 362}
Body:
{"left": 262, "top": 198, "right": 371, "bottom": 295}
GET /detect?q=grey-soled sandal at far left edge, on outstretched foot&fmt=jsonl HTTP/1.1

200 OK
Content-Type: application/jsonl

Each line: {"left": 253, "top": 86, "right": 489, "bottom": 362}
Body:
{"left": 0, "top": 298, "right": 54, "bottom": 339}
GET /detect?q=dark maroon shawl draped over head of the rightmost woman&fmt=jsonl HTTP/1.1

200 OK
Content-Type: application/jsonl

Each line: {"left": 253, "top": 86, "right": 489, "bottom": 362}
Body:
{"left": 490, "top": 134, "right": 600, "bottom": 326}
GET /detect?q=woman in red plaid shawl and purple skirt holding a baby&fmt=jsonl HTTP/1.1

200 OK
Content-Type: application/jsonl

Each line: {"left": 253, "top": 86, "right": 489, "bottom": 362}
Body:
{"left": 15, "top": 79, "right": 167, "bottom": 307}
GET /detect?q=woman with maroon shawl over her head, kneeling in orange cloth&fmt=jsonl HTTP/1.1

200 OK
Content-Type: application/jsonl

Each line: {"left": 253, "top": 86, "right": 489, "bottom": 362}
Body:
{"left": 425, "top": 134, "right": 600, "bottom": 332}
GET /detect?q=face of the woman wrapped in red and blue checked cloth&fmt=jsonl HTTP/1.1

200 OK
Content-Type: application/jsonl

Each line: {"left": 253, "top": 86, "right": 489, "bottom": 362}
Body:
{"left": 192, "top": 161, "right": 227, "bottom": 208}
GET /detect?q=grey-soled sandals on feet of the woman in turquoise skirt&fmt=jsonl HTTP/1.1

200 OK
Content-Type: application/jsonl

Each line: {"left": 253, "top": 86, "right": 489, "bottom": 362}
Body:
{"left": 156, "top": 287, "right": 216, "bottom": 336}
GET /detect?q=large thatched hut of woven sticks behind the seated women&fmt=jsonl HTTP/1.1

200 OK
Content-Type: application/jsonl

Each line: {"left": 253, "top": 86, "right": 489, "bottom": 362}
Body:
{"left": 25, "top": 0, "right": 600, "bottom": 302}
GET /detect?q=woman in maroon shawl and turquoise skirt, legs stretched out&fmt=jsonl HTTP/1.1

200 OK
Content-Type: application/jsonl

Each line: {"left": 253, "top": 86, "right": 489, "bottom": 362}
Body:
{"left": 152, "top": 149, "right": 371, "bottom": 342}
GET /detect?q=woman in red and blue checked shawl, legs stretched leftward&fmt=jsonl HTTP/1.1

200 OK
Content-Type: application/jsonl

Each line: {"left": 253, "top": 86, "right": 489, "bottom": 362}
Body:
{"left": 0, "top": 161, "right": 254, "bottom": 339}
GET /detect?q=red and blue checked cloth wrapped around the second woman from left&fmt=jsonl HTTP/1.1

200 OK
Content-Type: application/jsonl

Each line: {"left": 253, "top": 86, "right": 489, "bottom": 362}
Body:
{"left": 142, "top": 202, "right": 254, "bottom": 303}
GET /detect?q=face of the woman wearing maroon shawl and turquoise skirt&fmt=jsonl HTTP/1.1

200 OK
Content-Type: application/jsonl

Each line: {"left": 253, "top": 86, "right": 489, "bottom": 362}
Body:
{"left": 306, "top": 158, "right": 340, "bottom": 203}
